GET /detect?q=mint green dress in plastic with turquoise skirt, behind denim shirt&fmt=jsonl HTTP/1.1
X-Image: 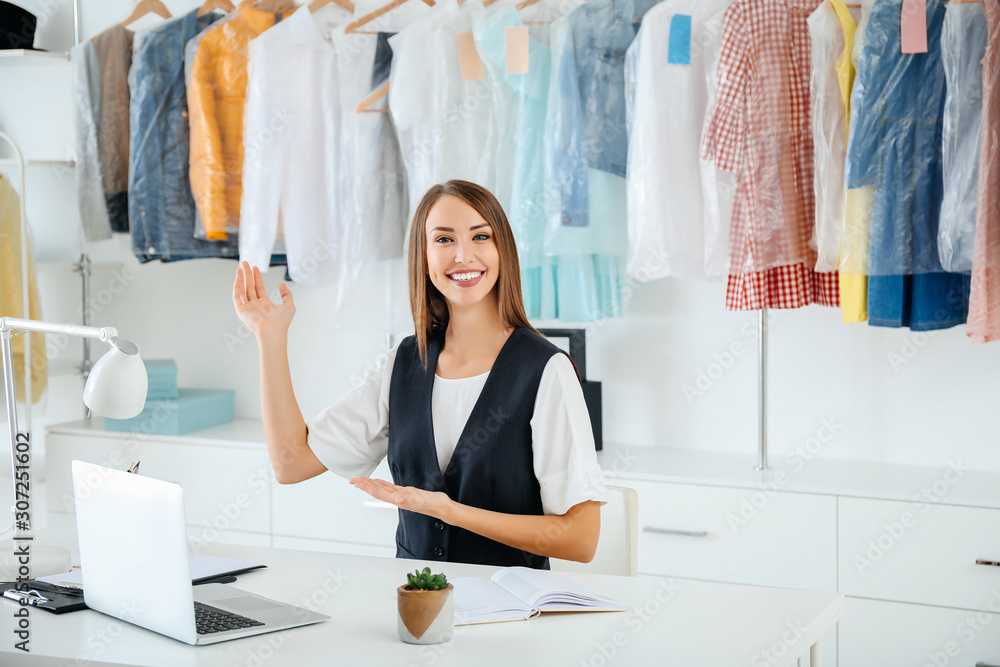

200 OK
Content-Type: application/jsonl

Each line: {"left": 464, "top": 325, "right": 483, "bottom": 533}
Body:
{"left": 476, "top": 3, "right": 625, "bottom": 322}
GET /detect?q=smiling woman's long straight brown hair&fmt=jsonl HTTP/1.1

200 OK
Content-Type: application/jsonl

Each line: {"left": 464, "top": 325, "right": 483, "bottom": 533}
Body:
{"left": 409, "top": 181, "right": 538, "bottom": 368}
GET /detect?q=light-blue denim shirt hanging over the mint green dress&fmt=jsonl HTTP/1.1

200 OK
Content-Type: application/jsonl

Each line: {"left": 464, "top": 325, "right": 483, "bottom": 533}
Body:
{"left": 551, "top": 0, "right": 659, "bottom": 227}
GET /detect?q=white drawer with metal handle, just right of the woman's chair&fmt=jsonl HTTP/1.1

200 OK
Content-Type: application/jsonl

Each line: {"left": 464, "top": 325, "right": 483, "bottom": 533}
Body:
{"left": 622, "top": 480, "right": 837, "bottom": 591}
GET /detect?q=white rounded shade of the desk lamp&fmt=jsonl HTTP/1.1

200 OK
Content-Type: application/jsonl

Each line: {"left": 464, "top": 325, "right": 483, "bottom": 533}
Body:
{"left": 83, "top": 338, "right": 149, "bottom": 419}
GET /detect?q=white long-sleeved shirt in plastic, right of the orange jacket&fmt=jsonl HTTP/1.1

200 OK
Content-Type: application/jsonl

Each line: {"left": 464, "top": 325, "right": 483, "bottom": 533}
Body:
{"left": 238, "top": 5, "right": 350, "bottom": 285}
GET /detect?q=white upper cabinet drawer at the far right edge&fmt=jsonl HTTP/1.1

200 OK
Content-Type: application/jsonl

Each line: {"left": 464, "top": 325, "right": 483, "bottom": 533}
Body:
{"left": 839, "top": 498, "right": 1000, "bottom": 612}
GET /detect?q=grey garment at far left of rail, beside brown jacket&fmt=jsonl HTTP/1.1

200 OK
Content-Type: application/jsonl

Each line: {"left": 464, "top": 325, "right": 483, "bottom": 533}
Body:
{"left": 70, "top": 42, "right": 111, "bottom": 241}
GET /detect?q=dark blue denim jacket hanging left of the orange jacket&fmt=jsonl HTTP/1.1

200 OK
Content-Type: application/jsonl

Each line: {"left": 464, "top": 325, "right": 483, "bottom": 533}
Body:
{"left": 128, "top": 10, "right": 239, "bottom": 262}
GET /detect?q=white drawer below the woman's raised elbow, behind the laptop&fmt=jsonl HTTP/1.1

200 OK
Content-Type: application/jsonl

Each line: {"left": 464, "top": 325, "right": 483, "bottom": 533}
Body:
{"left": 272, "top": 461, "right": 399, "bottom": 553}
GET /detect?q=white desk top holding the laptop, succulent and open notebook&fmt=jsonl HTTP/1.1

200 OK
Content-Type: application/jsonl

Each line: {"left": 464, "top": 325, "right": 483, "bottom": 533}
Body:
{"left": 0, "top": 518, "right": 844, "bottom": 667}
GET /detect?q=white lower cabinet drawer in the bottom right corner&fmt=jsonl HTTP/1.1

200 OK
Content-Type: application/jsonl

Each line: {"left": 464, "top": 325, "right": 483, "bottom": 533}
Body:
{"left": 837, "top": 597, "right": 1000, "bottom": 667}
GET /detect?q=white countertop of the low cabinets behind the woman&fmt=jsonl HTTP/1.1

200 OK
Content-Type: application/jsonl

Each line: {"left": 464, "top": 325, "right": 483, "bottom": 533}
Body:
{"left": 48, "top": 418, "right": 1000, "bottom": 509}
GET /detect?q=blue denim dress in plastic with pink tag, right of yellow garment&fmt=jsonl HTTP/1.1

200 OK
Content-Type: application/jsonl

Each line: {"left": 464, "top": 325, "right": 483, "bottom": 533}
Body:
{"left": 845, "top": 0, "right": 969, "bottom": 330}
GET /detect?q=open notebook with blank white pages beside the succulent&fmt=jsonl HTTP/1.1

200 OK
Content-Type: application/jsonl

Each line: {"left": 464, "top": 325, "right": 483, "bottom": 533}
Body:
{"left": 451, "top": 567, "right": 628, "bottom": 625}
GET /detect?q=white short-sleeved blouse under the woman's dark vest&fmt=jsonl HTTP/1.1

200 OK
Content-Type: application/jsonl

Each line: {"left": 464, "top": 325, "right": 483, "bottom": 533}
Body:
{"left": 307, "top": 346, "right": 607, "bottom": 515}
